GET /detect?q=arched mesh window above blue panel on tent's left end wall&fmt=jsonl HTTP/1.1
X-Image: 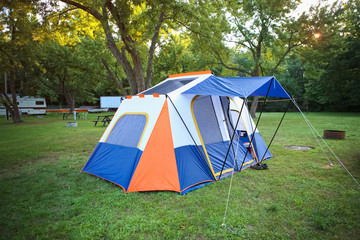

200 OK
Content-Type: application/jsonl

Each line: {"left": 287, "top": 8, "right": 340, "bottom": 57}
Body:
{"left": 106, "top": 114, "right": 147, "bottom": 147}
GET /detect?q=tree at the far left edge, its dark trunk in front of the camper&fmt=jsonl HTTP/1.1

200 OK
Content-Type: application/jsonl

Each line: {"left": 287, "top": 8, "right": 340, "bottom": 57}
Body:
{"left": 0, "top": 0, "right": 43, "bottom": 123}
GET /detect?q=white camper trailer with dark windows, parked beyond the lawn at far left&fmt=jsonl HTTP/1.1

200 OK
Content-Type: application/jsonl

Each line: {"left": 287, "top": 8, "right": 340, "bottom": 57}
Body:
{"left": 0, "top": 96, "right": 46, "bottom": 116}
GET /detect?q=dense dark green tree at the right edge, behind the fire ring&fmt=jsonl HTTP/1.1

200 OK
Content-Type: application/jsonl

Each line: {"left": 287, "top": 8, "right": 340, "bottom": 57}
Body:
{"left": 302, "top": 0, "right": 360, "bottom": 111}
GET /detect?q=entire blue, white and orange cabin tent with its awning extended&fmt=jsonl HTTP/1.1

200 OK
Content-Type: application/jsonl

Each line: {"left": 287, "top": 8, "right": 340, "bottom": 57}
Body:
{"left": 82, "top": 71, "right": 289, "bottom": 194}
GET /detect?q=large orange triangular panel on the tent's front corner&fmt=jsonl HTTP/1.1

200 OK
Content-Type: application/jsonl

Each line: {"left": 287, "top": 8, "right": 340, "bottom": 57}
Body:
{"left": 128, "top": 101, "right": 180, "bottom": 192}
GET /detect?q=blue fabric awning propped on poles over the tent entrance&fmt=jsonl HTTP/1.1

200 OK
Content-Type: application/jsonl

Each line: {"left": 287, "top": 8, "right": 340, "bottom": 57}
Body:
{"left": 182, "top": 75, "right": 290, "bottom": 98}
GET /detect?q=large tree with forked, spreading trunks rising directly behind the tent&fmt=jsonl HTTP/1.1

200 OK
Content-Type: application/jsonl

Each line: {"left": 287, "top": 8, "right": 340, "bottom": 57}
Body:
{"left": 57, "top": 0, "right": 182, "bottom": 94}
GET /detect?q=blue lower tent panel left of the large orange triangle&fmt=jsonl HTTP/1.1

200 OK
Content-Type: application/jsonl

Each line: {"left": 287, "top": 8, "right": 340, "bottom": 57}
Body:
{"left": 82, "top": 142, "right": 142, "bottom": 191}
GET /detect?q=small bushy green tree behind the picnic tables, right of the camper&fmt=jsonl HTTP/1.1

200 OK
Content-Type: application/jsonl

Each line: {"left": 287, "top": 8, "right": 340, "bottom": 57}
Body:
{"left": 38, "top": 39, "right": 104, "bottom": 112}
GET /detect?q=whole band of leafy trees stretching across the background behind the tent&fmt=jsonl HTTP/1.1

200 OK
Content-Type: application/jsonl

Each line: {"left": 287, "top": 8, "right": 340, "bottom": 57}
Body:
{"left": 0, "top": 0, "right": 360, "bottom": 122}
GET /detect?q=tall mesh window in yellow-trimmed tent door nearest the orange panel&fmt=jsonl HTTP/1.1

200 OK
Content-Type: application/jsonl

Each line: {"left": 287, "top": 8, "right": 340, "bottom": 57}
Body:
{"left": 193, "top": 96, "right": 223, "bottom": 144}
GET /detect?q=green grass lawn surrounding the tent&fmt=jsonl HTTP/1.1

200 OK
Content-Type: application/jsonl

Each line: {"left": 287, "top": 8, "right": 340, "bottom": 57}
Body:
{"left": 0, "top": 113, "right": 360, "bottom": 239}
